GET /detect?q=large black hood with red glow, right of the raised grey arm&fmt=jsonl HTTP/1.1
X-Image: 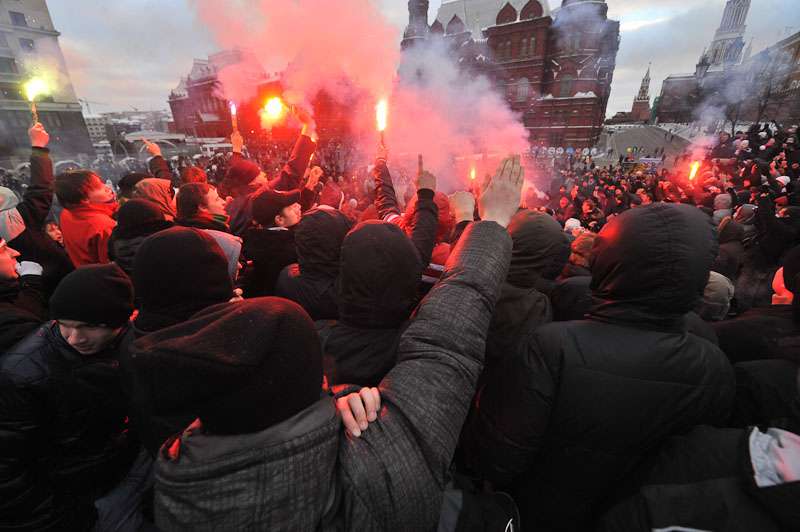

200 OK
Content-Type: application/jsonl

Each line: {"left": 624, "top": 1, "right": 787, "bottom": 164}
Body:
{"left": 590, "top": 203, "right": 718, "bottom": 330}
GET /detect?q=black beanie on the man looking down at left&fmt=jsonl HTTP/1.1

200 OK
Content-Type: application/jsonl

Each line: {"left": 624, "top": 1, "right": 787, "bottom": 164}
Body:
{"left": 50, "top": 263, "right": 133, "bottom": 328}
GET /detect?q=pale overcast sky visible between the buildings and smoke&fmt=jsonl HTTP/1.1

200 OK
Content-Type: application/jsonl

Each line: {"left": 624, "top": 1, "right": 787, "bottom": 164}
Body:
{"left": 47, "top": 0, "right": 800, "bottom": 116}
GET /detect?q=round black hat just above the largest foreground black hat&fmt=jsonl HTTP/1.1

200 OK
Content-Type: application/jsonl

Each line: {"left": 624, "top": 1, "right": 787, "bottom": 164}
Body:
{"left": 133, "top": 227, "right": 233, "bottom": 330}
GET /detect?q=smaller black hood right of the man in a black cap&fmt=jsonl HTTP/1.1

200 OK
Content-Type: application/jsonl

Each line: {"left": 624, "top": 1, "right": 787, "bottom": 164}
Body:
{"left": 294, "top": 207, "right": 353, "bottom": 279}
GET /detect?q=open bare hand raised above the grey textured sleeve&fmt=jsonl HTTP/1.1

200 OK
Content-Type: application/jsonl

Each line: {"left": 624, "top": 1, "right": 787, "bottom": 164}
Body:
{"left": 478, "top": 155, "right": 525, "bottom": 227}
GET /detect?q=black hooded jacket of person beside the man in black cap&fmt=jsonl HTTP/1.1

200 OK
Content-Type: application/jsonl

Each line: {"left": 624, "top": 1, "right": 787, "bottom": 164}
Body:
{"left": 275, "top": 207, "right": 352, "bottom": 320}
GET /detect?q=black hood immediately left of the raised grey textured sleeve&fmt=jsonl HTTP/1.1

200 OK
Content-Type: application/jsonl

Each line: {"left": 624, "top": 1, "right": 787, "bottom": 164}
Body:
{"left": 339, "top": 221, "right": 422, "bottom": 329}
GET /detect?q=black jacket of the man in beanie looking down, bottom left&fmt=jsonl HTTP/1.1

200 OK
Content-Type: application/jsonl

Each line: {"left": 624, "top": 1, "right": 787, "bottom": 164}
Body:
{"left": 0, "top": 322, "right": 138, "bottom": 530}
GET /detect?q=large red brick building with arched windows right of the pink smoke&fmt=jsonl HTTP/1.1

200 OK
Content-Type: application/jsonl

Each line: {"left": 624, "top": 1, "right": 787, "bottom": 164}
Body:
{"left": 418, "top": 0, "right": 619, "bottom": 148}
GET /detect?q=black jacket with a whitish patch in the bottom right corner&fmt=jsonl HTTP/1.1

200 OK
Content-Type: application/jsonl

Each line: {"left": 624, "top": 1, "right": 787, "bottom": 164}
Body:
{"left": 597, "top": 426, "right": 800, "bottom": 532}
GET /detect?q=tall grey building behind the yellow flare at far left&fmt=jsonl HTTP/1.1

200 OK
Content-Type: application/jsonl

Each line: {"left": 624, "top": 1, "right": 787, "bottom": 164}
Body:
{"left": 0, "top": 0, "right": 94, "bottom": 165}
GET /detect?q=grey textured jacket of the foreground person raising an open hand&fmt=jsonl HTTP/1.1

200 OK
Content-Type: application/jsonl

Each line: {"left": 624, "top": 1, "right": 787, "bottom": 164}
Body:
{"left": 155, "top": 222, "right": 511, "bottom": 531}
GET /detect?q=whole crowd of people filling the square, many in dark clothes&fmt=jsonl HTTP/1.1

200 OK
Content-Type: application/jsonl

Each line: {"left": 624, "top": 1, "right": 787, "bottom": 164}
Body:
{"left": 0, "top": 108, "right": 800, "bottom": 531}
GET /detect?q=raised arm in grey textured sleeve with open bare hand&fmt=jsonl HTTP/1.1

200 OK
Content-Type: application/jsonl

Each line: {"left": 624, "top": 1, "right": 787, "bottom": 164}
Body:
{"left": 346, "top": 157, "right": 522, "bottom": 529}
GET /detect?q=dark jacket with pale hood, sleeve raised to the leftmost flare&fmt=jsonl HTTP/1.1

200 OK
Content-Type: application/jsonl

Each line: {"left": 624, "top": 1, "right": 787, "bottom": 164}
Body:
{"left": 0, "top": 148, "right": 74, "bottom": 295}
